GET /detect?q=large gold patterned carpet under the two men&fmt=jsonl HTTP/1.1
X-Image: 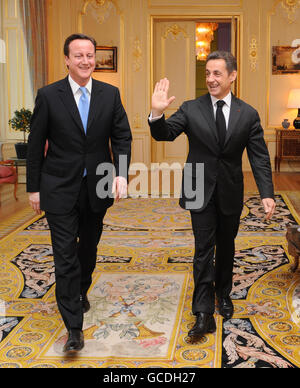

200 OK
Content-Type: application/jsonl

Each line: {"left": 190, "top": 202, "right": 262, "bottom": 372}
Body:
{"left": 0, "top": 192, "right": 300, "bottom": 368}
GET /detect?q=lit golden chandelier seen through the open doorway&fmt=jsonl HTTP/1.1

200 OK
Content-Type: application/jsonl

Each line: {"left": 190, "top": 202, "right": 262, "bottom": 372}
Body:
{"left": 196, "top": 23, "right": 219, "bottom": 61}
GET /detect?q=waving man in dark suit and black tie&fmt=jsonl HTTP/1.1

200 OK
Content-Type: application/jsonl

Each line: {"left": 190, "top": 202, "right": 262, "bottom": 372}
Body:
{"left": 149, "top": 51, "right": 275, "bottom": 341}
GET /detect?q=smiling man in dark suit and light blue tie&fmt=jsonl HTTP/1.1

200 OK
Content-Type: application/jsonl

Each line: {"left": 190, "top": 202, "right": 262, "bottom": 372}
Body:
{"left": 27, "top": 34, "right": 132, "bottom": 352}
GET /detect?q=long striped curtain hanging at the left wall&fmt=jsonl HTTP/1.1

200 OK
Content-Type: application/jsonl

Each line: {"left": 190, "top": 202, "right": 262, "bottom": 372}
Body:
{"left": 19, "top": 0, "right": 48, "bottom": 95}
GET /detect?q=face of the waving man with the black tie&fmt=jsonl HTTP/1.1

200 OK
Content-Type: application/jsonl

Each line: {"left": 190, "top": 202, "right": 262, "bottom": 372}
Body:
{"left": 206, "top": 59, "right": 237, "bottom": 100}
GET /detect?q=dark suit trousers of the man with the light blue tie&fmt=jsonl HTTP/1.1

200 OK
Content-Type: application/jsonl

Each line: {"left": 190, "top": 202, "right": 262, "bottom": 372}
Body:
{"left": 46, "top": 178, "right": 106, "bottom": 330}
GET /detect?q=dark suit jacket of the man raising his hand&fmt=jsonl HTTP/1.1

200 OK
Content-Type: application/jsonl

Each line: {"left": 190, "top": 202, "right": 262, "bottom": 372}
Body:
{"left": 149, "top": 94, "right": 274, "bottom": 215}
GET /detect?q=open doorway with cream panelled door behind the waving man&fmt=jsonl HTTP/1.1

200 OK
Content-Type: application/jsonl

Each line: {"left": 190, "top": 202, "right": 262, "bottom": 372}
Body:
{"left": 151, "top": 16, "right": 240, "bottom": 194}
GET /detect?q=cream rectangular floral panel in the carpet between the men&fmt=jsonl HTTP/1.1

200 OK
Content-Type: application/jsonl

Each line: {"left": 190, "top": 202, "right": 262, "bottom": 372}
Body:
{"left": 45, "top": 273, "right": 187, "bottom": 360}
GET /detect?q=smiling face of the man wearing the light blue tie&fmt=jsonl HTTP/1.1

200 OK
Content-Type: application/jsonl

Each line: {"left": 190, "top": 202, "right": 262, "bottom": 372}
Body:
{"left": 65, "top": 39, "right": 96, "bottom": 86}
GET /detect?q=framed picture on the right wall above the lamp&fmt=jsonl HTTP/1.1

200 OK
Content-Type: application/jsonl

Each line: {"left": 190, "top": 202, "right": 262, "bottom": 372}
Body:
{"left": 272, "top": 46, "right": 300, "bottom": 74}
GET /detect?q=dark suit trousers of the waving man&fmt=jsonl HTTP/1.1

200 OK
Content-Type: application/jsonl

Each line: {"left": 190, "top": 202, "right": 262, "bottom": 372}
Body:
{"left": 191, "top": 189, "right": 240, "bottom": 315}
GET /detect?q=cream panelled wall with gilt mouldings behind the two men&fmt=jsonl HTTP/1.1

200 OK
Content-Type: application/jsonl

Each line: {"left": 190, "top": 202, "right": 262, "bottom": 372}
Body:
{"left": 44, "top": 0, "right": 300, "bottom": 170}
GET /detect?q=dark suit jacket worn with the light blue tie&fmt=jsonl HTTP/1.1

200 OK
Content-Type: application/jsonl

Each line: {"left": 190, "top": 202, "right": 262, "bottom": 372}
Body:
{"left": 27, "top": 77, "right": 132, "bottom": 214}
